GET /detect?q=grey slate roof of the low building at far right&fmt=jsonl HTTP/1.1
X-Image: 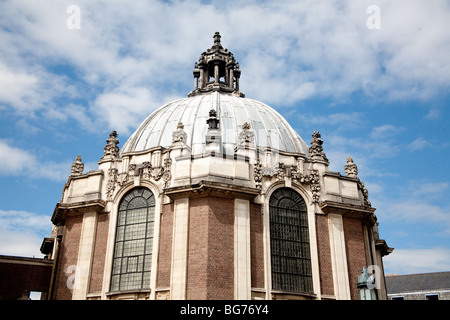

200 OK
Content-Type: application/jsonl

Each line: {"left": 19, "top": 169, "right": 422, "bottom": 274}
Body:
{"left": 386, "top": 272, "right": 450, "bottom": 294}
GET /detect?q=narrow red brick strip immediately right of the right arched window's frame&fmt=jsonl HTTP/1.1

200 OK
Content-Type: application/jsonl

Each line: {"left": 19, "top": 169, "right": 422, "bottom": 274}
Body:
{"left": 316, "top": 214, "right": 334, "bottom": 296}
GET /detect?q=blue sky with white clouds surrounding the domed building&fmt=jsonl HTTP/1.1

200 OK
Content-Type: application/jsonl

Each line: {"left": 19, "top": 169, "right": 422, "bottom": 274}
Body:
{"left": 0, "top": 0, "right": 450, "bottom": 274}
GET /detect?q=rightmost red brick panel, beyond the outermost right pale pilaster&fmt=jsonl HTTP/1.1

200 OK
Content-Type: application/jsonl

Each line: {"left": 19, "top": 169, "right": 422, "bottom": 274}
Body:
{"left": 343, "top": 217, "right": 367, "bottom": 300}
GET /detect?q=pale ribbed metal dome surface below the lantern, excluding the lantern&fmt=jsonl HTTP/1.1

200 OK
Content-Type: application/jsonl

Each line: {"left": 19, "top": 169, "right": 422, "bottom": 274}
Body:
{"left": 121, "top": 92, "right": 308, "bottom": 155}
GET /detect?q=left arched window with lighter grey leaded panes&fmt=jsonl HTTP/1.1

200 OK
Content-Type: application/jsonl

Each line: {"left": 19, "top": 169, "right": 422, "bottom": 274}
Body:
{"left": 110, "top": 188, "right": 155, "bottom": 291}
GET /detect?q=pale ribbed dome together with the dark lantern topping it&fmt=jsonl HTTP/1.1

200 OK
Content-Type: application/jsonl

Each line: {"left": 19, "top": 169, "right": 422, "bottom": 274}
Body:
{"left": 121, "top": 32, "right": 308, "bottom": 155}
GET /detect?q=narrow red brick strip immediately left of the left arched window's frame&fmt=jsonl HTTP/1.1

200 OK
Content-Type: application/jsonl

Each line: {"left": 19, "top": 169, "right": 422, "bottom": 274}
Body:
{"left": 89, "top": 213, "right": 109, "bottom": 293}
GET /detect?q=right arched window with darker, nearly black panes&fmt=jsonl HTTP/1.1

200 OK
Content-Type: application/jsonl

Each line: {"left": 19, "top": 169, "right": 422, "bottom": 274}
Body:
{"left": 269, "top": 188, "right": 313, "bottom": 293}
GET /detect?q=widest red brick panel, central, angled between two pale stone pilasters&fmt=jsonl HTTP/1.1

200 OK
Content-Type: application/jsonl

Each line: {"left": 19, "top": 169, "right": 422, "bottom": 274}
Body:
{"left": 187, "top": 196, "right": 234, "bottom": 300}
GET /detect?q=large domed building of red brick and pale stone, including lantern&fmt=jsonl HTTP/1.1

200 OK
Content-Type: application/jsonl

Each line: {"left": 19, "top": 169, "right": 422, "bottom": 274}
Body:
{"left": 43, "top": 33, "right": 392, "bottom": 299}
